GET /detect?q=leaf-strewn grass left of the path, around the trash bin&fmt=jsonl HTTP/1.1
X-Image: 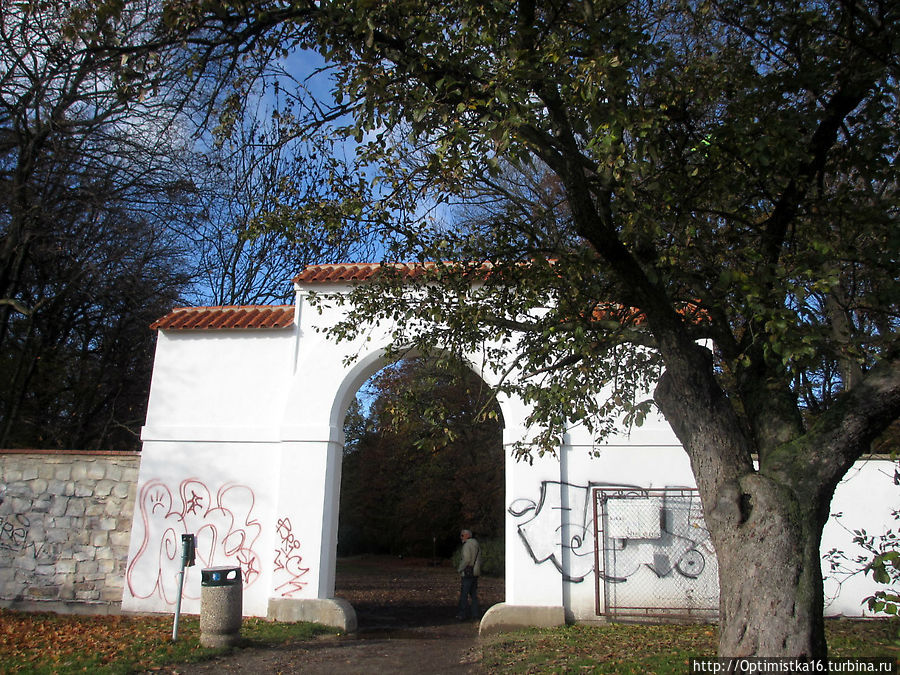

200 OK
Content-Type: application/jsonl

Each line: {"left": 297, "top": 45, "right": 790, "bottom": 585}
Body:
{"left": 0, "top": 610, "right": 334, "bottom": 673}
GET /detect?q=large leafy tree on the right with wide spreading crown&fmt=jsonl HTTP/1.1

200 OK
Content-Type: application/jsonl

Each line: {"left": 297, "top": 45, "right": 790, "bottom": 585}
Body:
{"left": 149, "top": 0, "right": 900, "bottom": 651}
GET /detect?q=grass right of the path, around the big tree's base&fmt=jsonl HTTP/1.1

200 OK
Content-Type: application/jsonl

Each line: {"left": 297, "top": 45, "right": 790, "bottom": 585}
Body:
{"left": 482, "top": 619, "right": 900, "bottom": 675}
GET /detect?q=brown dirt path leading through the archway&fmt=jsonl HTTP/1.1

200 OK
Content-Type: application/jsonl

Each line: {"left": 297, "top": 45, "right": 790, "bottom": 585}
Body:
{"left": 178, "top": 557, "right": 503, "bottom": 675}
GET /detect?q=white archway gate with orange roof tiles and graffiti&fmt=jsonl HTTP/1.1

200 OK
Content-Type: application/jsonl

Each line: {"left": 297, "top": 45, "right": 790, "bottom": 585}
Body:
{"left": 122, "top": 265, "right": 897, "bottom": 630}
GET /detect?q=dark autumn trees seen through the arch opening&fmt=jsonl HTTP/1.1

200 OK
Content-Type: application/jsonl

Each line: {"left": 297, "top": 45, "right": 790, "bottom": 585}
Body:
{"left": 338, "top": 359, "right": 504, "bottom": 557}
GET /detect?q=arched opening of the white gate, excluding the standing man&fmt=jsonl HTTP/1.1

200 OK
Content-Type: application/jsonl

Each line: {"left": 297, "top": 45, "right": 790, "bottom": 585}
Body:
{"left": 335, "top": 355, "right": 505, "bottom": 630}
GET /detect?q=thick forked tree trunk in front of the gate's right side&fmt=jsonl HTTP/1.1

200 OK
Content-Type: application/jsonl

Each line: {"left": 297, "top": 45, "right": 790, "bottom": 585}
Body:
{"left": 654, "top": 340, "right": 900, "bottom": 658}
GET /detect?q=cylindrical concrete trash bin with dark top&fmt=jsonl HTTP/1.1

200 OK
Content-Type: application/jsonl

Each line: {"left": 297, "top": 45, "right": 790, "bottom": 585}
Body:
{"left": 200, "top": 567, "right": 244, "bottom": 647}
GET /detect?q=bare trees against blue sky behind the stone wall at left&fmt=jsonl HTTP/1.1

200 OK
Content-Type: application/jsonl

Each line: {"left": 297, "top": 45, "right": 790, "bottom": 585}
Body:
{"left": 0, "top": 0, "right": 368, "bottom": 449}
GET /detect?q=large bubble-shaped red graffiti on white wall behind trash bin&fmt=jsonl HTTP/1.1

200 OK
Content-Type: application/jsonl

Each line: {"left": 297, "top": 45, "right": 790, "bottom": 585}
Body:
{"left": 125, "top": 478, "right": 262, "bottom": 604}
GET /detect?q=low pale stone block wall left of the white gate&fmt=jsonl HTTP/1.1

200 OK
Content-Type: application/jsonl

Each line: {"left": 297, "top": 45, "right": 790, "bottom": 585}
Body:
{"left": 0, "top": 450, "right": 140, "bottom": 613}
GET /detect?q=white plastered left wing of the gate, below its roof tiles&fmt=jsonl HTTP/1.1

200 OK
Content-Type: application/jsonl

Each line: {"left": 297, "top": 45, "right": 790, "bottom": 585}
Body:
{"left": 122, "top": 329, "right": 296, "bottom": 616}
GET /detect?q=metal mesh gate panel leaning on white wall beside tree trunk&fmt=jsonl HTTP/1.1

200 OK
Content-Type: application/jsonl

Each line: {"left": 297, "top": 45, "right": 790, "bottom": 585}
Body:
{"left": 593, "top": 488, "right": 719, "bottom": 619}
